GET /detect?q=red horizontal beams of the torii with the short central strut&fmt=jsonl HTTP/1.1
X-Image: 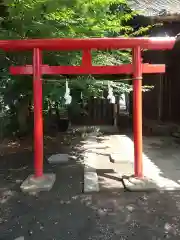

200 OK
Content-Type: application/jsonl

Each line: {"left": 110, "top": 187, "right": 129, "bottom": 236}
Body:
{"left": 8, "top": 37, "right": 176, "bottom": 75}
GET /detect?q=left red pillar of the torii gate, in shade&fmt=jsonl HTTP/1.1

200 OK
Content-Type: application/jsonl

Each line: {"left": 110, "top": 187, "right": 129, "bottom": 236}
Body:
{"left": 33, "top": 48, "right": 43, "bottom": 177}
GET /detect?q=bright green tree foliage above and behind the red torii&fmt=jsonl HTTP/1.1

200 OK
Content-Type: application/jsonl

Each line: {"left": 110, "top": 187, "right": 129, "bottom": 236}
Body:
{"left": 0, "top": 0, "right": 153, "bottom": 135}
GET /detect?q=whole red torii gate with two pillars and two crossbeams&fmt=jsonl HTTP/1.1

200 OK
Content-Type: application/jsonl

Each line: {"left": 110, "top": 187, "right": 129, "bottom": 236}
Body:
{"left": 0, "top": 37, "right": 175, "bottom": 191}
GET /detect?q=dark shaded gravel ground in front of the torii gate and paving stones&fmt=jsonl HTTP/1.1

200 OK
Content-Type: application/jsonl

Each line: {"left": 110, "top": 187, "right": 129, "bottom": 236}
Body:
{"left": 0, "top": 130, "right": 180, "bottom": 240}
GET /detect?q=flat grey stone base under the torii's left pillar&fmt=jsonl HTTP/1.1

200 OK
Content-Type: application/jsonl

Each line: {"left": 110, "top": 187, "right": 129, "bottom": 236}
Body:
{"left": 21, "top": 173, "right": 56, "bottom": 193}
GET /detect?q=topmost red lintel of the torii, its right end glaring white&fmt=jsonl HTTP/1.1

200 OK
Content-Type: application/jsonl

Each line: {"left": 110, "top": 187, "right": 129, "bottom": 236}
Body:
{"left": 0, "top": 37, "right": 176, "bottom": 51}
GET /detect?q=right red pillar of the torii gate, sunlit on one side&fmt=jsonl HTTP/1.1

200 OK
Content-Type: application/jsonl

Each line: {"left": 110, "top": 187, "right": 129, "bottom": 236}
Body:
{"left": 133, "top": 47, "right": 143, "bottom": 178}
